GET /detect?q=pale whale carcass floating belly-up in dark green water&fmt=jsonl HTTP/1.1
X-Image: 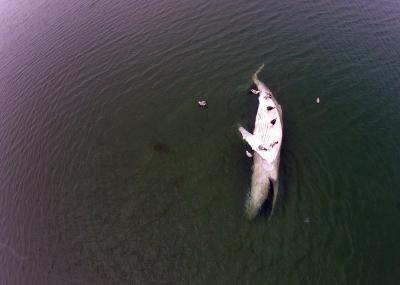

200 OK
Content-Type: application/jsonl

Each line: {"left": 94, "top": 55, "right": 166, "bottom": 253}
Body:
{"left": 239, "top": 65, "right": 283, "bottom": 219}
